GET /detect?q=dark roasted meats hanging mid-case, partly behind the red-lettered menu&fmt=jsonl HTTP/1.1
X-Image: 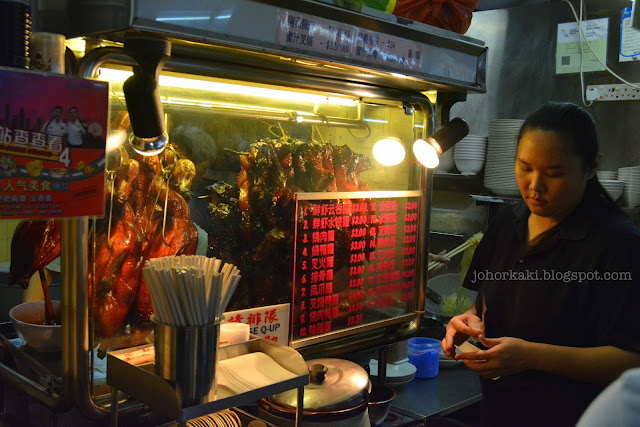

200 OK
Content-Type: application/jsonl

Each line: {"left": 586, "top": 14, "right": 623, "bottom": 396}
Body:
{"left": 207, "top": 136, "right": 375, "bottom": 312}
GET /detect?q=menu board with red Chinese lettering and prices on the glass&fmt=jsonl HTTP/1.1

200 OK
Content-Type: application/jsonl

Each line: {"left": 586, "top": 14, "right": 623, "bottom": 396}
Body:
{"left": 292, "top": 191, "right": 422, "bottom": 341}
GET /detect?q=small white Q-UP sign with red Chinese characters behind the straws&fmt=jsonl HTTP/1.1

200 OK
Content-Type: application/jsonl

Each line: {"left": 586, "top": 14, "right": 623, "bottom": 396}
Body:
{"left": 224, "top": 304, "right": 289, "bottom": 345}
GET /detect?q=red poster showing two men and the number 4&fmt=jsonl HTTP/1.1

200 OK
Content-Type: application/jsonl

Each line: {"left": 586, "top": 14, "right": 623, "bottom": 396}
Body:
{"left": 0, "top": 68, "right": 109, "bottom": 219}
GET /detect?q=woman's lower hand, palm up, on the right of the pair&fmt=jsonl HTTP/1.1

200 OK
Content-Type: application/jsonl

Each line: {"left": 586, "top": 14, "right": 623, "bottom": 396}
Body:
{"left": 455, "top": 334, "right": 532, "bottom": 378}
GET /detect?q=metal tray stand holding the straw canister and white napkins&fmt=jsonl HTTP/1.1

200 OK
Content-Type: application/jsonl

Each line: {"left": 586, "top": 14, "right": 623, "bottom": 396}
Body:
{"left": 107, "top": 336, "right": 309, "bottom": 427}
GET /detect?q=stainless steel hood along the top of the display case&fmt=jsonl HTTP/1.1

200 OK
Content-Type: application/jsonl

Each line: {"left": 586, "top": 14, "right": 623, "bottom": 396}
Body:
{"left": 67, "top": 0, "right": 487, "bottom": 93}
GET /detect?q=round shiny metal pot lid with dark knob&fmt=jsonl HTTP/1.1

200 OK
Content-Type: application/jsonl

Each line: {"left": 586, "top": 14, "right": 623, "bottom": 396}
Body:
{"left": 270, "top": 359, "right": 369, "bottom": 412}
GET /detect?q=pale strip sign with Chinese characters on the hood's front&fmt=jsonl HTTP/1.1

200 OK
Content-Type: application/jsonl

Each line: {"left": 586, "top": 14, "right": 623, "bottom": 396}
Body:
{"left": 276, "top": 9, "right": 423, "bottom": 71}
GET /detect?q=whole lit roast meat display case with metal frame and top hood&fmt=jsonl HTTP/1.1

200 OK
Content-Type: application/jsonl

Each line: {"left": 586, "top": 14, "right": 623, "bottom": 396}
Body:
{"left": 0, "top": 1, "right": 486, "bottom": 418}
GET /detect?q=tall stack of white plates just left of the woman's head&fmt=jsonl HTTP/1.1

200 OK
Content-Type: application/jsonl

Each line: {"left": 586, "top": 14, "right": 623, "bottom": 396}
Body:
{"left": 484, "top": 119, "right": 524, "bottom": 197}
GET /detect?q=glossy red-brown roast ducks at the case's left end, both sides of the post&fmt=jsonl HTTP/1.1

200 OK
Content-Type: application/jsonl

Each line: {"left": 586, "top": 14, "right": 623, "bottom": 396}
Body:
{"left": 9, "top": 145, "right": 198, "bottom": 338}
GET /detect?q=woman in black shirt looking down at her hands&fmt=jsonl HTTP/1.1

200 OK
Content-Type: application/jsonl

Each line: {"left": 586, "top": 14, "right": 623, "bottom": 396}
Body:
{"left": 442, "top": 103, "right": 640, "bottom": 426}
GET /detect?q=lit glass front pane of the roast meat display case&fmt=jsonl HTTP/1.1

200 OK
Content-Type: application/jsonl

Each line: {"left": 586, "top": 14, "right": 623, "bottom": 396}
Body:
{"left": 89, "top": 57, "right": 430, "bottom": 349}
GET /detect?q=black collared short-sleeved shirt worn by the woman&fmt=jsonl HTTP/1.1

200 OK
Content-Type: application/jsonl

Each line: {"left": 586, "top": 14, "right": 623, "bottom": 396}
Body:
{"left": 464, "top": 193, "right": 640, "bottom": 425}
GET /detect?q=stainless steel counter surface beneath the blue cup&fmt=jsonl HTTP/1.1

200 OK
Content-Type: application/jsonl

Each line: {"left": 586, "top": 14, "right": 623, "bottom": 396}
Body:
{"left": 392, "top": 366, "right": 482, "bottom": 418}
